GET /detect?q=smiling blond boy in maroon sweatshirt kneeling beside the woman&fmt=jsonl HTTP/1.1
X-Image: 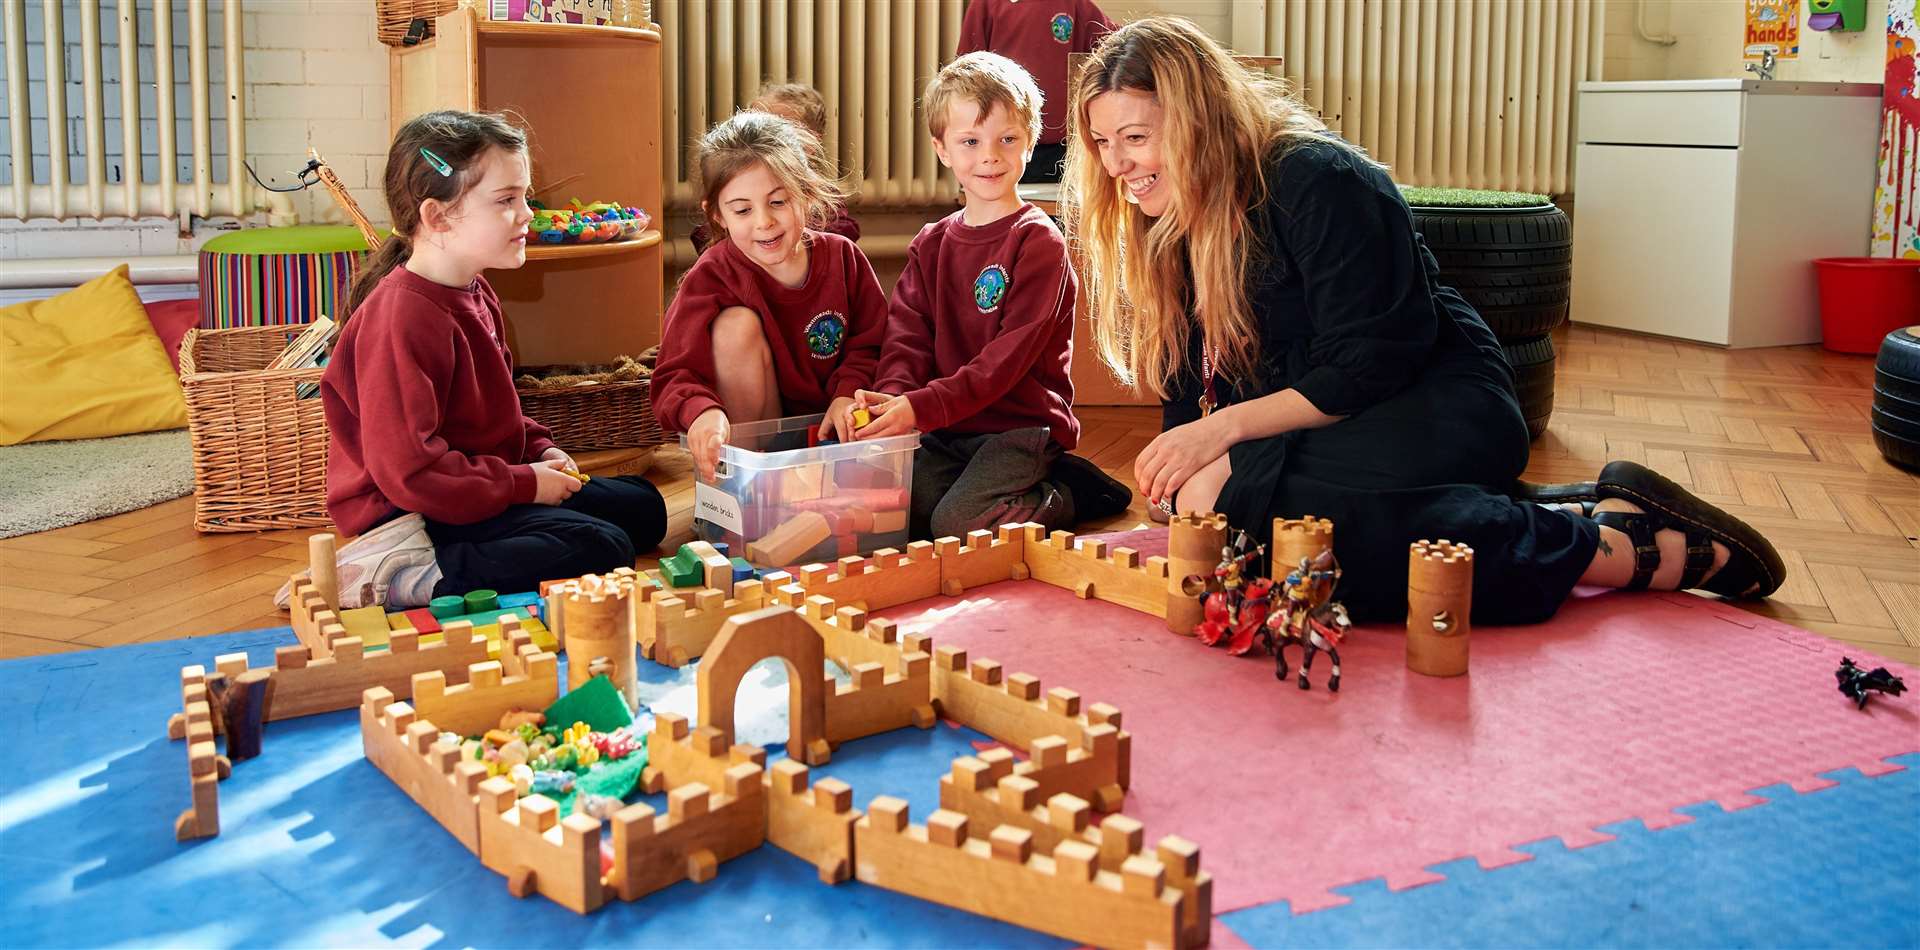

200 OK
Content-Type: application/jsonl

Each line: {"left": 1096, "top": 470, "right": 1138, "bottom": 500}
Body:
{"left": 856, "top": 54, "right": 1079, "bottom": 537}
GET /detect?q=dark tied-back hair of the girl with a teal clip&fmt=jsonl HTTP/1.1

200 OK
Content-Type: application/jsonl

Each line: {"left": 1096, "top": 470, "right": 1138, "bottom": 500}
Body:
{"left": 342, "top": 109, "right": 526, "bottom": 322}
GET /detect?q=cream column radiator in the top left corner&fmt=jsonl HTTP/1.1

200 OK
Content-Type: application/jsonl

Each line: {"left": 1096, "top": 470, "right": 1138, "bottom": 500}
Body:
{"left": 0, "top": 0, "right": 284, "bottom": 221}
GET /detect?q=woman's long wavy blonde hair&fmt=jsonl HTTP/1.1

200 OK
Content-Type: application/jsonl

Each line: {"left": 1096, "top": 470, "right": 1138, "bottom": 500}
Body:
{"left": 1062, "top": 17, "right": 1352, "bottom": 399}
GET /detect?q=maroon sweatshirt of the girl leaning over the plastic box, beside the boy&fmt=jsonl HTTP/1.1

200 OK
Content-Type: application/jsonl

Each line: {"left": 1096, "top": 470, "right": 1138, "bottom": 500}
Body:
{"left": 653, "top": 230, "right": 887, "bottom": 432}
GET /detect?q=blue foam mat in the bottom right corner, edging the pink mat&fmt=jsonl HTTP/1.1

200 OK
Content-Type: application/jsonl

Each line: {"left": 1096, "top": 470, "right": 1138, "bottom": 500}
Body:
{"left": 1223, "top": 754, "right": 1920, "bottom": 946}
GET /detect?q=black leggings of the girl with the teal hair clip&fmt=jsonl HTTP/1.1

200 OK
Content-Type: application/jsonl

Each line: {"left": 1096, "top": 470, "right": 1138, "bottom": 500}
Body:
{"left": 426, "top": 476, "right": 666, "bottom": 597}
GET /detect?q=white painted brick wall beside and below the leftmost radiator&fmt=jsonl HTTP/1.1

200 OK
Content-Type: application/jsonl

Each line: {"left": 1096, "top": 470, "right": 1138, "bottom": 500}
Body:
{"left": 17, "top": 0, "right": 390, "bottom": 259}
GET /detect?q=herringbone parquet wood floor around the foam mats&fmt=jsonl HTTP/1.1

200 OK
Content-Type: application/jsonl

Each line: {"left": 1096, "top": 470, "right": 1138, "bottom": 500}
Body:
{"left": 0, "top": 326, "right": 1920, "bottom": 664}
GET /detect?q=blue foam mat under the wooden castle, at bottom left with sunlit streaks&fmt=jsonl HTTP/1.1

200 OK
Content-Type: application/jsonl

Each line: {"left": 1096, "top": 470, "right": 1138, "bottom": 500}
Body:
{"left": 0, "top": 629, "right": 1066, "bottom": 946}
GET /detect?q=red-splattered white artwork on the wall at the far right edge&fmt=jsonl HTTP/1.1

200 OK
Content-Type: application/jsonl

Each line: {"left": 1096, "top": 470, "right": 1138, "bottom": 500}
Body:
{"left": 1870, "top": 0, "right": 1920, "bottom": 259}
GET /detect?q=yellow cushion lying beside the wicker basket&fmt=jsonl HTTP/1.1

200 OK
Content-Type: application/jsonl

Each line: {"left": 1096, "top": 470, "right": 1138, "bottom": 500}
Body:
{"left": 0, "top": 265, "right": 186, "bottom": 445}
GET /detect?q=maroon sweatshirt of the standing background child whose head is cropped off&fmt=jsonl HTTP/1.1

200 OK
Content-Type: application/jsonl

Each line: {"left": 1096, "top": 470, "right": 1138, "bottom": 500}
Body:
{"left": 954, "top": 0, "right": 1114, "bottom": 146}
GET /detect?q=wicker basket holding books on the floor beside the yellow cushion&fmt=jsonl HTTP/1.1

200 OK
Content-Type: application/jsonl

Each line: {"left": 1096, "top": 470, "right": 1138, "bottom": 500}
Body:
{"left": 180, "top": 324, "right": 328, "bottom": 532}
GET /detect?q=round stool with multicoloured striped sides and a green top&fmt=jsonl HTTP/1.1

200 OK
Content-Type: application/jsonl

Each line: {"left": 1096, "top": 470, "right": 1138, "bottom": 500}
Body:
{"left": 200, "top": 225, "right": 367, "bottom": 330}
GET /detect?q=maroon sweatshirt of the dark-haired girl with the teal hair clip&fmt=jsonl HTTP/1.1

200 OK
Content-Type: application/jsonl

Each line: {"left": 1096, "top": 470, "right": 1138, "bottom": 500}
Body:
{"left": 321, "top": 267, "right": 553, "bottom": 535}
